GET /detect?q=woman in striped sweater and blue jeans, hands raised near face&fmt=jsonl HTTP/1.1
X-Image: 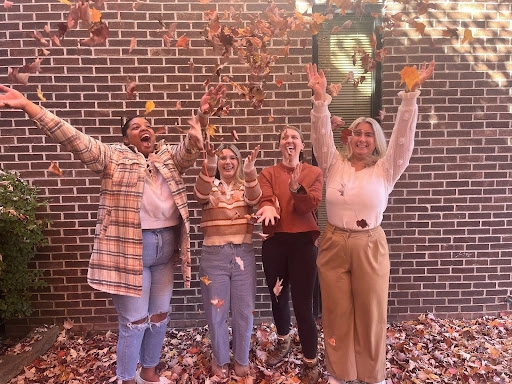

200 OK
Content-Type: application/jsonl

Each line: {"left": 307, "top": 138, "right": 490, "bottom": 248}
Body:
{"left": 194, "top": 144, "right": 261, "bottom": 378}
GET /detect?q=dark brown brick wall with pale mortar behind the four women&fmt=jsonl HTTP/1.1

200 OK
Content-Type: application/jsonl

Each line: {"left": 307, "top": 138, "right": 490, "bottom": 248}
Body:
{"left": 0, "top": 0, "right": 512, "bottom": 336}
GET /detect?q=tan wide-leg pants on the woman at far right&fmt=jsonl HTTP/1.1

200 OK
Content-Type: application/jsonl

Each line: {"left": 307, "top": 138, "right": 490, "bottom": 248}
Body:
{"left": 317, "top": 224, "right": 390, "bottom": 383}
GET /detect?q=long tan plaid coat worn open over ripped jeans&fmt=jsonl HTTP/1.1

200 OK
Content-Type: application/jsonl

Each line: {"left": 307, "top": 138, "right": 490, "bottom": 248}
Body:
{"left": 33, "top": 109, "right": 199, "bottom": 297}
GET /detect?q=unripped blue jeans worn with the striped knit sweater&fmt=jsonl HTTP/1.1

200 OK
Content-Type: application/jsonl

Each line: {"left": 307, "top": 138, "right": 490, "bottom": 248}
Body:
{"left": 199, "top": 243, "right": 256, "bottom": 365}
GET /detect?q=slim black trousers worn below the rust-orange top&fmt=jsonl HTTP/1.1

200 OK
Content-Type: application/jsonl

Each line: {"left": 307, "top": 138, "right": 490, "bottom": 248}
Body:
{"left": 262, "top": 232, "right": 318, "bottom": 359}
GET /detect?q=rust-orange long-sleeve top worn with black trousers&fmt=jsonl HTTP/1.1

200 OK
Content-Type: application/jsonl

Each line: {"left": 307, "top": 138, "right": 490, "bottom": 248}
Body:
{"left": 258, "top": 163, "right": 324, "bottom": 240}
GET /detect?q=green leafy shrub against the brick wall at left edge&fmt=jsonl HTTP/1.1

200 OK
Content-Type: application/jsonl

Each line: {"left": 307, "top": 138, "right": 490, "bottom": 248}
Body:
{"left": 0, "top": 170, "right": 47, "bottom": 323}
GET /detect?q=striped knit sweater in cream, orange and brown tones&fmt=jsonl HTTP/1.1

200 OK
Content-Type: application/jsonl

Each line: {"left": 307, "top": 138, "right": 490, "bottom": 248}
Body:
{"left": 194, "top": 161, "right": 261, "bottom": 245}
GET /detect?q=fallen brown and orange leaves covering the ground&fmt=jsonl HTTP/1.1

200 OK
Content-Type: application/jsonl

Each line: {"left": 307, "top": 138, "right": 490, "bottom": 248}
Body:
{"left": 4, "top": 314, "right": 512, "bottom": 384}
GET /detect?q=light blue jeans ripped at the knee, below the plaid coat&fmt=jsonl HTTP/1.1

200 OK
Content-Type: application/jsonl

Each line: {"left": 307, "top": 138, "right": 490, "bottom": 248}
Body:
{"left": 112, "top": 228, "right": 176, "bottom": 380}
